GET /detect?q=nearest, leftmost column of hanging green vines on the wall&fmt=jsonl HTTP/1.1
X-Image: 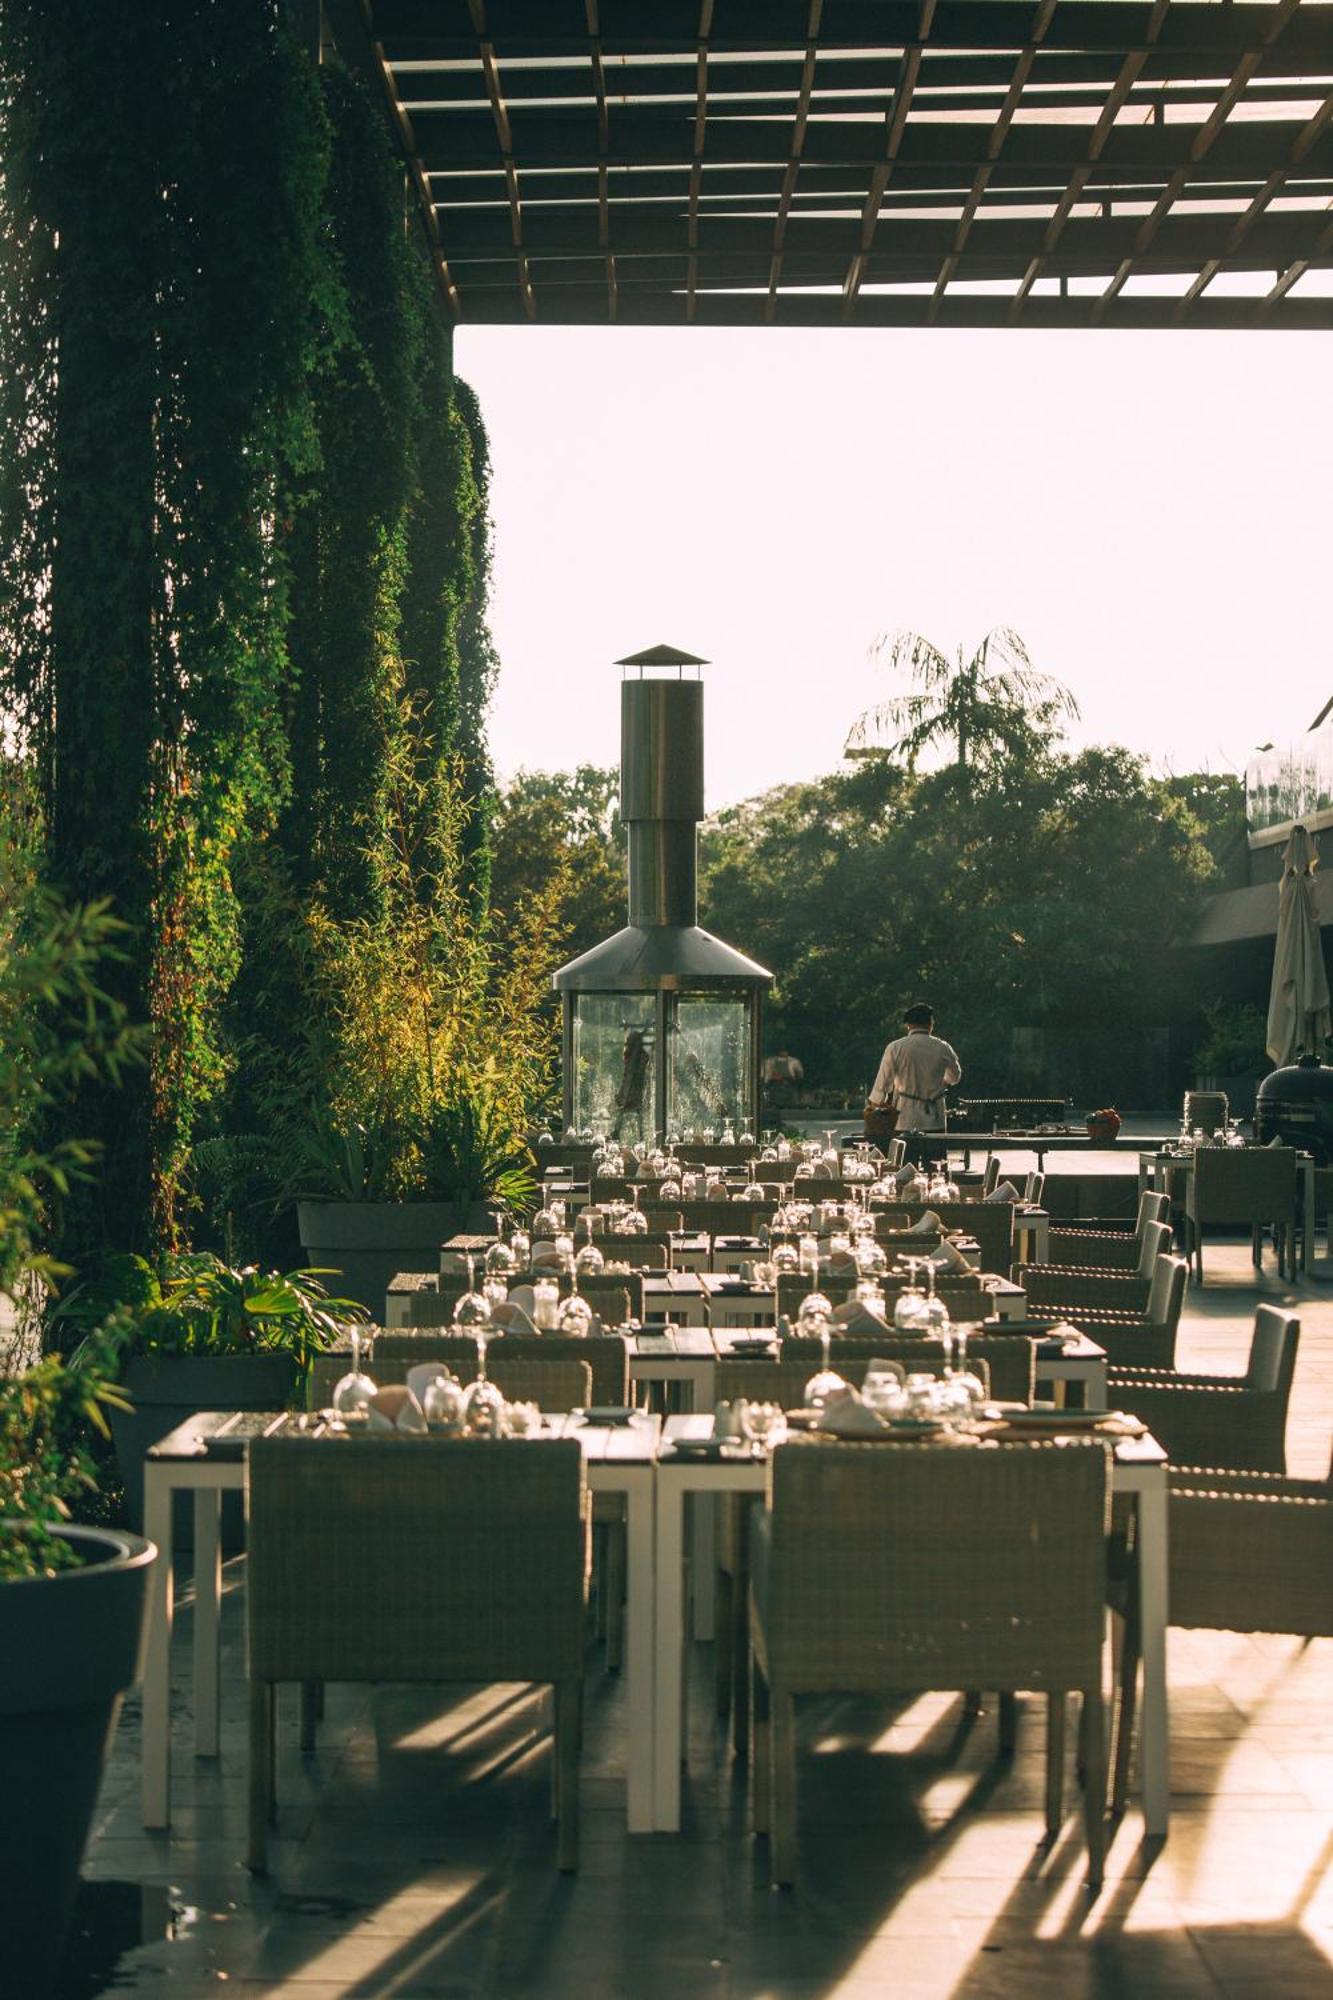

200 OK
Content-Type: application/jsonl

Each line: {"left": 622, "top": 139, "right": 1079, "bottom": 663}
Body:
{"left": 0, "top": 0, "right": 334, "bottom": 1252}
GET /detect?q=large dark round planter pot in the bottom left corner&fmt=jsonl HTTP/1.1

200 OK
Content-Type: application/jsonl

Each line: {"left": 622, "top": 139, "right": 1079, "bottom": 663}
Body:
{"left": 0, "top": 1528, "right": 158, "bottom": 2000}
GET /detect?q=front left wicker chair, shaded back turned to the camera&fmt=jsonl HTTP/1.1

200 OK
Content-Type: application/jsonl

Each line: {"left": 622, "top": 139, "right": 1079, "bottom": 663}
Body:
{"left": 246, "top": 1438, "right": 588, "bottom": 1874}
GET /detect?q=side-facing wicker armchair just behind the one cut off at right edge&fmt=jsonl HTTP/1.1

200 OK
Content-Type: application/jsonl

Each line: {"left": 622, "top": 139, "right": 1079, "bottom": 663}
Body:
{"left": 1107, "top": 1306, "right": 1301, "bottom": 1472}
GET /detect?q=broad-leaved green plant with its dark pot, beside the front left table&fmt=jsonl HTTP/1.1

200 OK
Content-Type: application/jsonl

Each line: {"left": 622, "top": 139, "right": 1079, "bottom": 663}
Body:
{"left": 52, "top": 1252, "right": 366, "bottom": 1546}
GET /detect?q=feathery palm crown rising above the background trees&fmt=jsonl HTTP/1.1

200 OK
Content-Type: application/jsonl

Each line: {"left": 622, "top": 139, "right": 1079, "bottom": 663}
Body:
{"left": 843, "top": 626, "right": 1079, "bottom": 784}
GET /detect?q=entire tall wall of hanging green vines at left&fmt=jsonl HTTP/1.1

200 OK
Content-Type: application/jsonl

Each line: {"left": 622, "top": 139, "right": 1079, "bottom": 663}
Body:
{"left": 0, "top": 0, "right": 504, "bottom": 1260}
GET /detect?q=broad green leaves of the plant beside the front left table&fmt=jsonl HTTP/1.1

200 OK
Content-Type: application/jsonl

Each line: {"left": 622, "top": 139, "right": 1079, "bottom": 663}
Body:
{"left": 56, "top": 1252, "right": 366, "bottom": 1368}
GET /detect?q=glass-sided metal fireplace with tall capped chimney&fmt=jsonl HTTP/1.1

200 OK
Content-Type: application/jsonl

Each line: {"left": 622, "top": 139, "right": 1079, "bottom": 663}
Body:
{"left": 552, "top": 646, "right": 773, "bottom": 1144}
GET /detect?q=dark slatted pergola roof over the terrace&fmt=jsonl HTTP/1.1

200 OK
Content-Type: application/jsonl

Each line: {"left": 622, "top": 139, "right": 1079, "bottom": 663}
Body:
{"left": 352, "top": 0, "right": 1333, "bottom": 328}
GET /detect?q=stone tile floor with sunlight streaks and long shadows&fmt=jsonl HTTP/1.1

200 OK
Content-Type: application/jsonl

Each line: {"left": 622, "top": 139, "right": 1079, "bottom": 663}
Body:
{"left": 62, "top": 1246, "right": 1333, "bottom": 2000}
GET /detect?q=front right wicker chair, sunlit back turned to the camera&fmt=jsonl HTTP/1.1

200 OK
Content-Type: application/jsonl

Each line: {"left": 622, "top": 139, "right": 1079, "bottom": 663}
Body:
{"left": 751, "top": 1440, "right": 1109, "bottom": 1888}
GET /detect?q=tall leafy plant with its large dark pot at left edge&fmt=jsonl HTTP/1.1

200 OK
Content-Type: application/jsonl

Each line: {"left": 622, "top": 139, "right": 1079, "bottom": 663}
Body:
{"left": 0, "top": 808, "right": 156, "bottom": 2000}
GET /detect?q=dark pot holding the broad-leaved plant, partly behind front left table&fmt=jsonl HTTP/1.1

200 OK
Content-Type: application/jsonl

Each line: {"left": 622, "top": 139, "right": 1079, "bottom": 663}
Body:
{"left": 108, "top": 1354, "right": 298, "bottom": 1550}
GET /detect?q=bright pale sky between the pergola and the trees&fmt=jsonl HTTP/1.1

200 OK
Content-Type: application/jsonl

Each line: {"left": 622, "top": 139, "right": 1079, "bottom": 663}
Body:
{"left": 456, "top": 326, "right": 1333, "bottom": 810}
